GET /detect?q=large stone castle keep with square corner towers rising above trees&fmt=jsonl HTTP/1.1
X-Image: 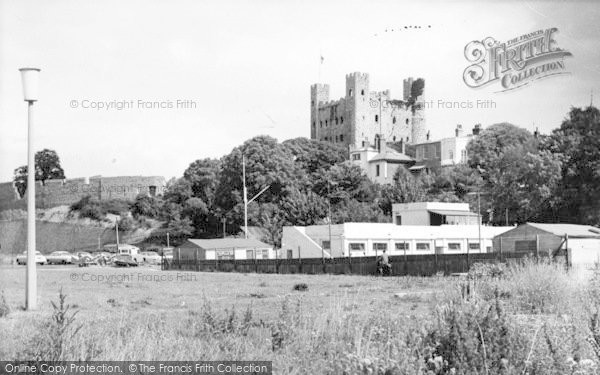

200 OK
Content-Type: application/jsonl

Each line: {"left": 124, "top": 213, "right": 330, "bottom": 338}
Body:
{"left": 310, "top": 72, "right": 428, "bottom": 152}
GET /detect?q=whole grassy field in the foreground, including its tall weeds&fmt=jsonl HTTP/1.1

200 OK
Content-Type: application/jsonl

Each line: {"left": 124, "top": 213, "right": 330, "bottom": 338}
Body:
{"left": 0, "top": 263, "right": 600, "bottom": 374}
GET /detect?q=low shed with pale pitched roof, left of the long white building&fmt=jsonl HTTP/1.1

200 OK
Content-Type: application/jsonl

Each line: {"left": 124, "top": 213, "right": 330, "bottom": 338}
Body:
{"left": 173, "top": 238, "right": 275, "bottom": 260}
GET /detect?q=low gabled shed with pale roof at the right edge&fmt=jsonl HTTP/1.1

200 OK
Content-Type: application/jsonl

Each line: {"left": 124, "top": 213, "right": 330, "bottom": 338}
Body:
{"left": 493, "top": 223, "right": 600, "bottom": 268}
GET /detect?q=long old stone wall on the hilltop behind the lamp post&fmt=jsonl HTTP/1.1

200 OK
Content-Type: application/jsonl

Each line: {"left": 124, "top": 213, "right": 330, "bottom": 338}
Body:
{"left": 0, "top": 176, "right": 166, "bottom": 211}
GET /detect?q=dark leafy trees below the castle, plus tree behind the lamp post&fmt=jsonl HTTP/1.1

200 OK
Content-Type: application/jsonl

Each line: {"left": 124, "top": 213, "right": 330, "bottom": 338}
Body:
{"left": 15, "top": 107, "right": 600, "bottom": 246}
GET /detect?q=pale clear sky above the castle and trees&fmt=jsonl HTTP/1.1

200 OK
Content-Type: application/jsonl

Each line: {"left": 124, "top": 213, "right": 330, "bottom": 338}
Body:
{"left": 0, "top": 0, "right": 600, "bottom": 181}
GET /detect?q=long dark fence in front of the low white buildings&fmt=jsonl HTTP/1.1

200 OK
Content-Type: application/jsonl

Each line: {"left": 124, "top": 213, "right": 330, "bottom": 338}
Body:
{"left": 162, "top": 252, "right": 548, "bottom": 276}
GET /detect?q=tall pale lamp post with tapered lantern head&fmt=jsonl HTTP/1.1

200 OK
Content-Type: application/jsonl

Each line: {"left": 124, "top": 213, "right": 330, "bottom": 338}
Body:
{"left": 19, "top": 68, "right": 40, "bottom": 310}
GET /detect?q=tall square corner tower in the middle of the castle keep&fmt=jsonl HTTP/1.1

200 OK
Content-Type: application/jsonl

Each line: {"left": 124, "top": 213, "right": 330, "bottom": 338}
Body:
{"left": 346, "top": 72, "right": 370, "bottom": 145}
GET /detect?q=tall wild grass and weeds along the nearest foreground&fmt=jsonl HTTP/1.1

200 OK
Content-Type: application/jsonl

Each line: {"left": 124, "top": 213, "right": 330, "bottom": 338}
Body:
{"left": 4, "top": 260, "right": 600, "bottom": 375}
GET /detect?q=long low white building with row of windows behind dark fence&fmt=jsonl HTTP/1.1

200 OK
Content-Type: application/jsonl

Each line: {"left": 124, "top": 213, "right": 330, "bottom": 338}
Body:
{"left": 281, "top": 223, "right": 513, "bottom": 259}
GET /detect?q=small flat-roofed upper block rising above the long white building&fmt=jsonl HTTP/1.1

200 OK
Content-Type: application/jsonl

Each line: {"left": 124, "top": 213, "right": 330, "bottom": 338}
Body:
{"left": 392, "top": 202, "right": 479, "bottom": 225}
